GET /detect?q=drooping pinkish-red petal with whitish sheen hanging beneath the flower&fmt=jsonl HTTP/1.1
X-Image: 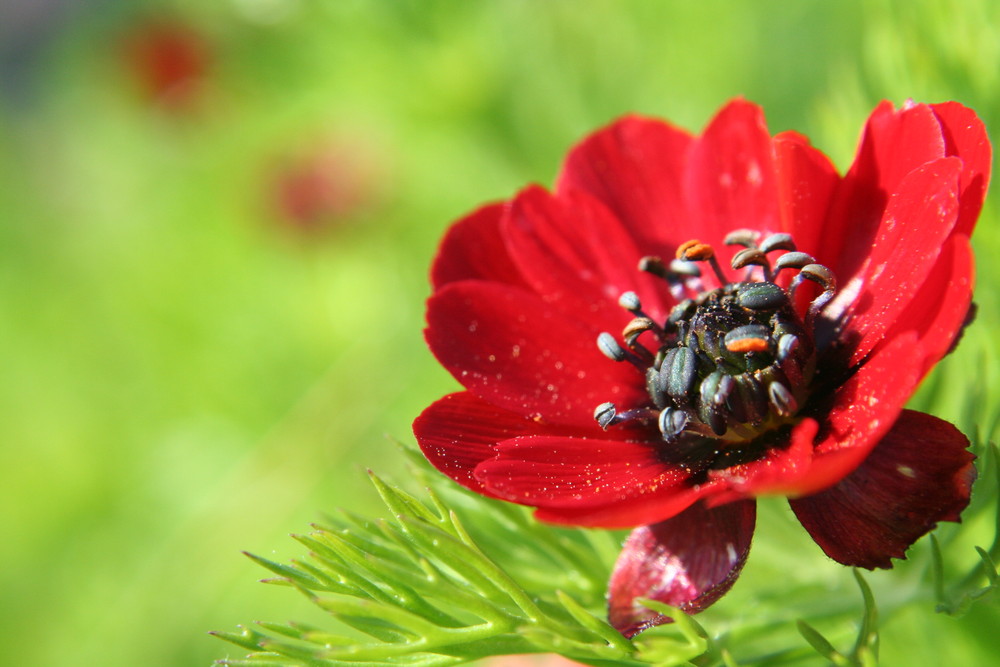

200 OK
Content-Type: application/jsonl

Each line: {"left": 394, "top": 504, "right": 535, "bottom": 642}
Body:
{"left": 608, "top": 500, "right": 757, "bottom": 638}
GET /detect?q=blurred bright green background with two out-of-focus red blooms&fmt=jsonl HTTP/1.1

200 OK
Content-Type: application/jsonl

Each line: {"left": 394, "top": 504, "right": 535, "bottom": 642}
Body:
{"left": 0, "top": 0, "right": 1000, "bottom": 667}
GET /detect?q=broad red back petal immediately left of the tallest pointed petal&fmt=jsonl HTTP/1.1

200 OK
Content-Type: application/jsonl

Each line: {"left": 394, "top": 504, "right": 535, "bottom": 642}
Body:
{"left": 556, "top": 116, "right": 698, "bottom": 256}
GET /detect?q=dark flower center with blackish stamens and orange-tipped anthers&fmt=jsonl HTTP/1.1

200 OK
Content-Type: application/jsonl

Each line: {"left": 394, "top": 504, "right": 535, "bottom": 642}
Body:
{"left": 594, "top": 230, "right": 836, "bottom": 444}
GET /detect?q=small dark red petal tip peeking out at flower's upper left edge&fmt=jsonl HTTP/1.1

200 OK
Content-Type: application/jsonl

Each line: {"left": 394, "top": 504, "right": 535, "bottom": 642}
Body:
{"left": 431, "top": 203, "right": 524, "bottom": 290}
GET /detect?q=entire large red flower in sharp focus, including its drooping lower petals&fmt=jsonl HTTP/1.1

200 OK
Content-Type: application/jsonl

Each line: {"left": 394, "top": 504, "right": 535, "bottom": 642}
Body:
{"left": 414, "top": 100, "right": 991, "bottom": 636}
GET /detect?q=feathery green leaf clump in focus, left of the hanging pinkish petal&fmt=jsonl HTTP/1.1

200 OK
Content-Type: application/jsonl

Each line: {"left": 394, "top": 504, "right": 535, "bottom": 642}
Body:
{"left": 215, "top": 456, "right": 709, "bottom": 665}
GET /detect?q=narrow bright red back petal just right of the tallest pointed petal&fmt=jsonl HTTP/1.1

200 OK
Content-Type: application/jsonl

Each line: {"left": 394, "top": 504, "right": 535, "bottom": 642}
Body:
{"left": 774, "top": 132, "right": 840, "bottom": 263}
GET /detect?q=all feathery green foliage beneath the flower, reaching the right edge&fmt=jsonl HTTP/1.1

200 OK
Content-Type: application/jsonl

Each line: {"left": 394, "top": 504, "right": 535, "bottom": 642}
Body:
{"left": 219, "top": 430, "right": 1000, "bottom": 667}
